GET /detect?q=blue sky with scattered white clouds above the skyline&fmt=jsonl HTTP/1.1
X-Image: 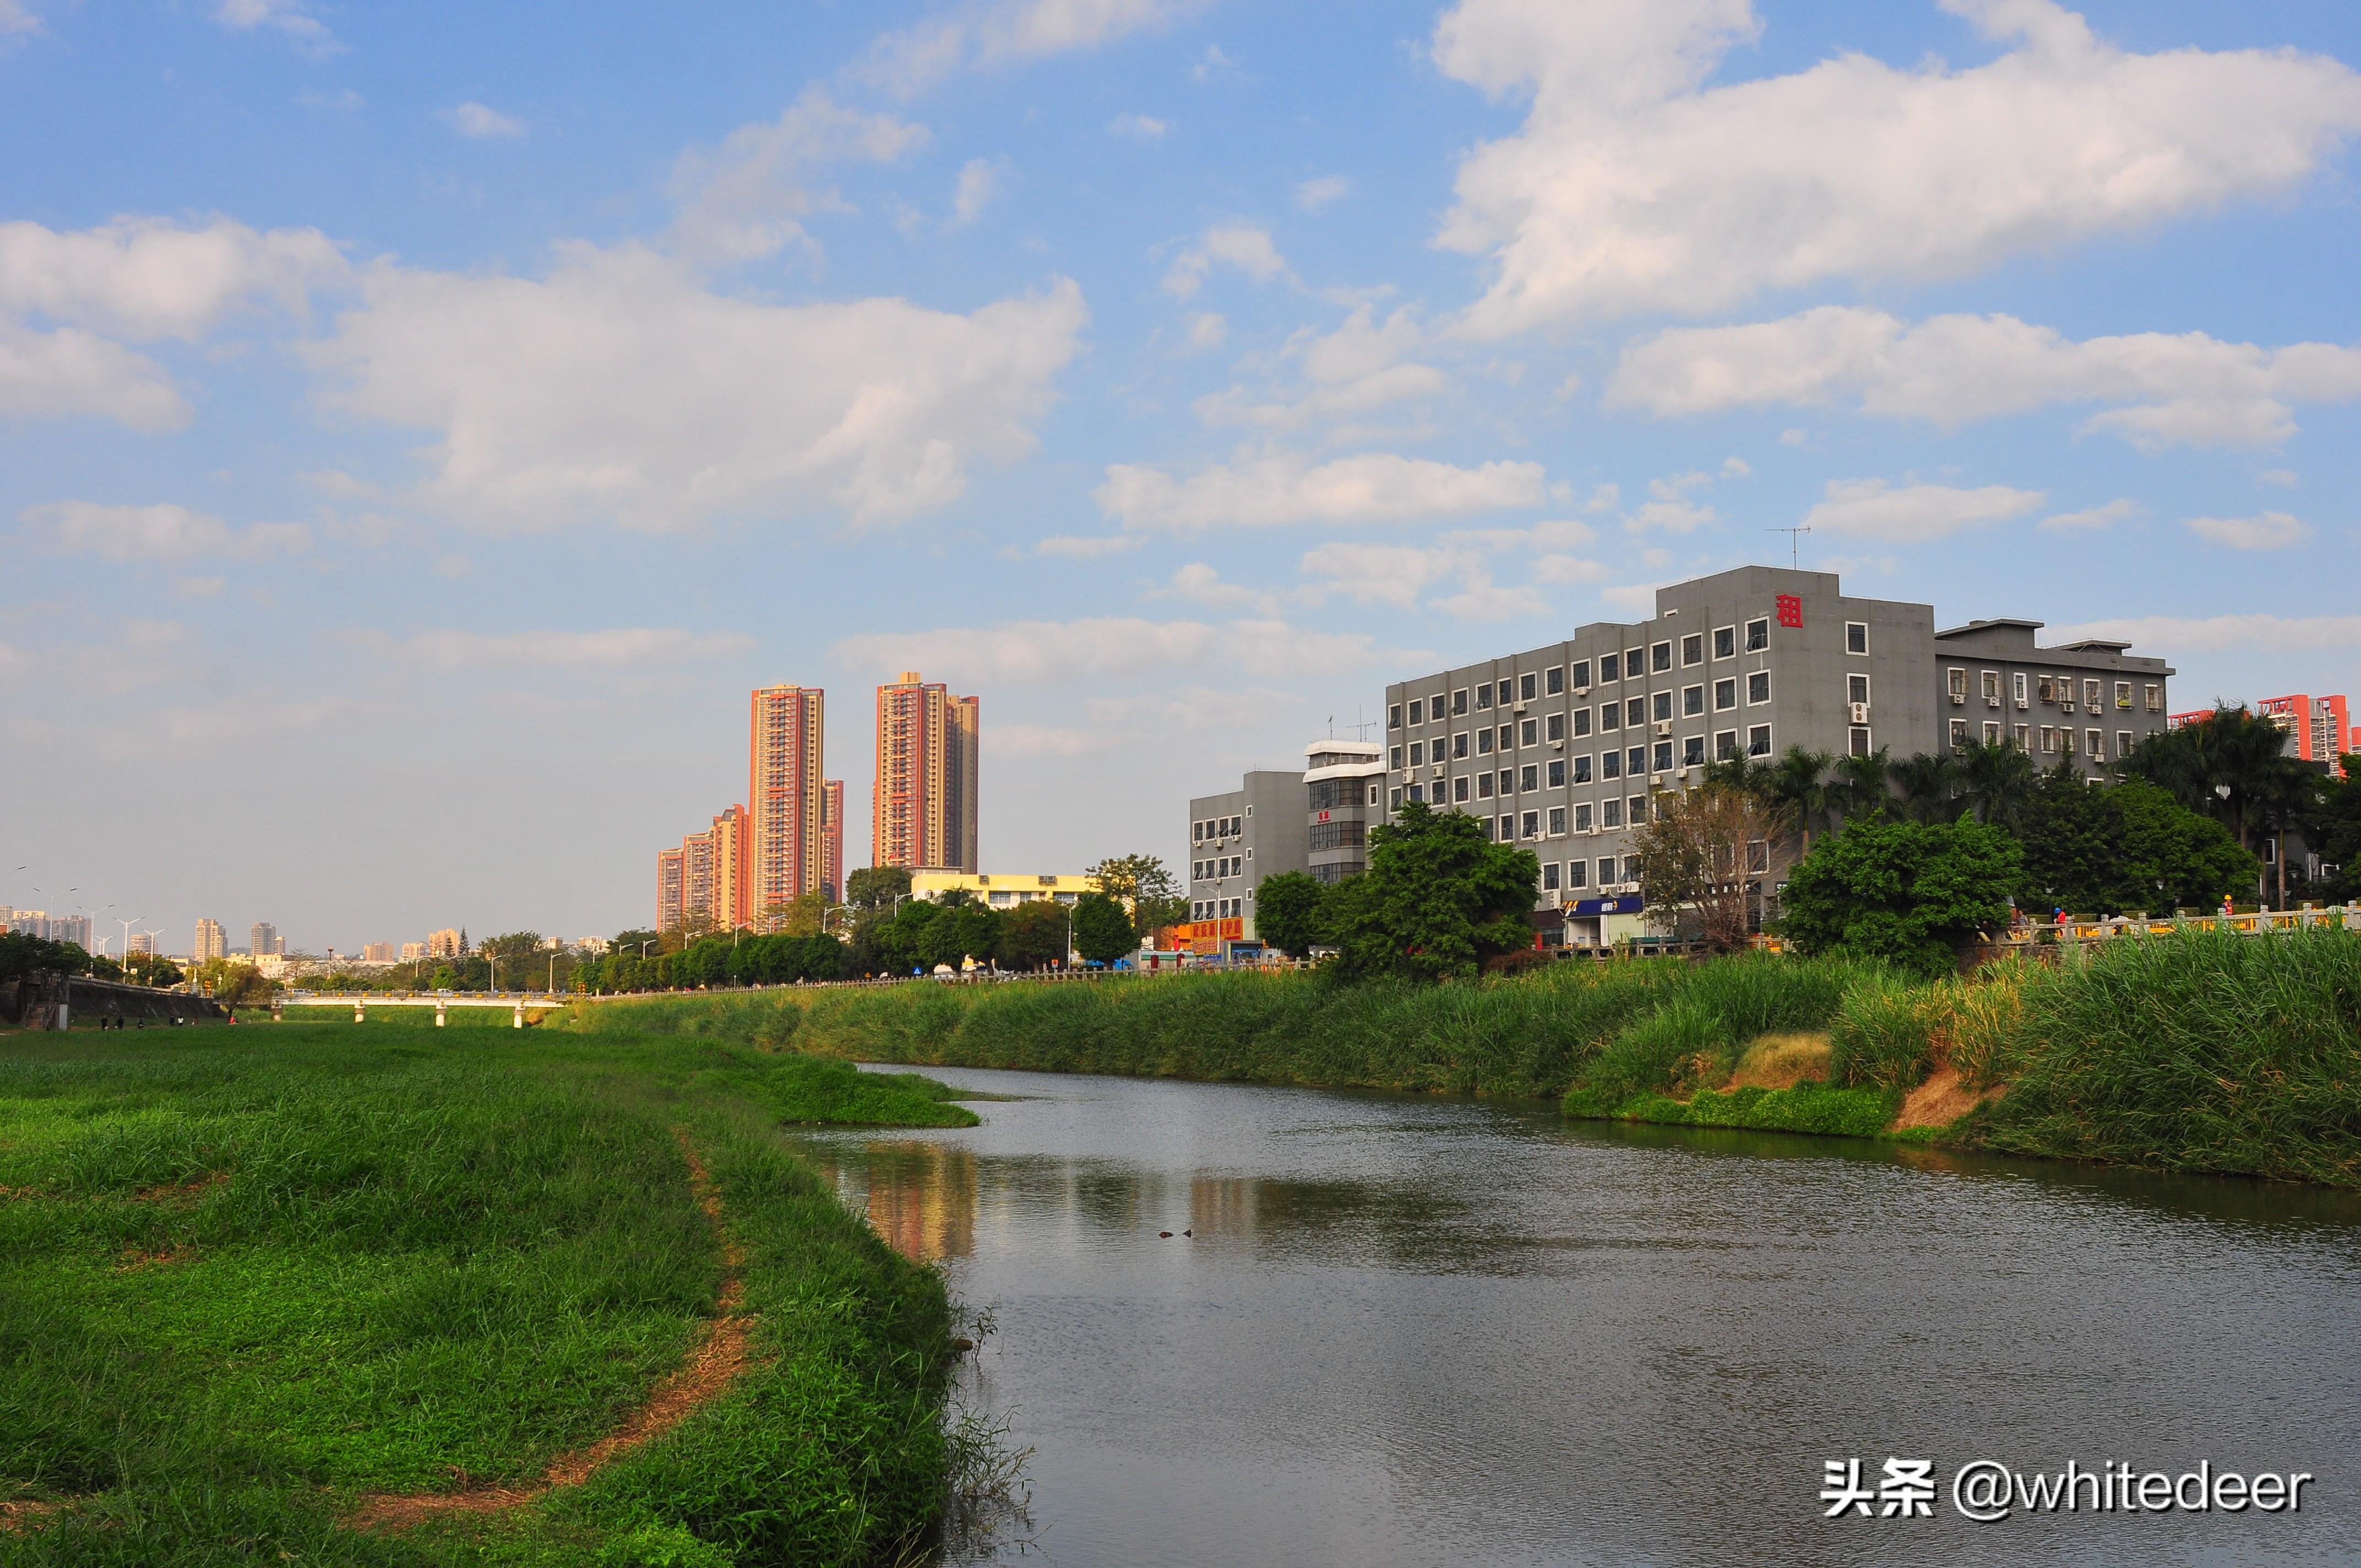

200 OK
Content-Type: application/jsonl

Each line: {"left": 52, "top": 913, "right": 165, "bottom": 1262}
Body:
{"left": 0, "top": 0, "right": 2361, "bottom": 949}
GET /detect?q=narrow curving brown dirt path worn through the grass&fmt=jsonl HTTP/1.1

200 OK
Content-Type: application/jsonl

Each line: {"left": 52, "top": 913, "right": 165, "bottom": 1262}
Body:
{"left": 350, "top": 1126, "right": 753, "bottom": 1530}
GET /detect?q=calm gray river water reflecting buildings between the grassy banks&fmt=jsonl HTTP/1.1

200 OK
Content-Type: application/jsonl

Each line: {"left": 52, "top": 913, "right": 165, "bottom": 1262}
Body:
{"left": 810, "top": 1070, "right": 2361, "bottom": 1568}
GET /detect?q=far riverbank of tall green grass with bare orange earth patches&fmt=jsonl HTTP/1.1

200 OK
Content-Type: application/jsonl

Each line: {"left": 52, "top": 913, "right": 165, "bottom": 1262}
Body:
{"left": 574, "top": 930, "right": 2361, "bottom": 1185}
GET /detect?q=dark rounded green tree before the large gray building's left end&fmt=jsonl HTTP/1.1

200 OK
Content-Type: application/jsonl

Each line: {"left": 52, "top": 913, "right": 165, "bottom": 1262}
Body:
{"left": 1329, "top": 801, "right": 1542, "bottom": 980}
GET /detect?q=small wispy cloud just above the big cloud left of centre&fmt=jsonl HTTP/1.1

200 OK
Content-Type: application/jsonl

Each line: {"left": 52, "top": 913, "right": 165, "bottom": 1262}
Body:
{"left": 673, "top": 88, "right": 930, "bottom": 262}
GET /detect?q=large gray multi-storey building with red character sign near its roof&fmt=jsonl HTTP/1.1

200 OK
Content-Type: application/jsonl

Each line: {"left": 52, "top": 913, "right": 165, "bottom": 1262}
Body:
{"left": 1386, "top": 567, "right": 2172, "bottom": 945}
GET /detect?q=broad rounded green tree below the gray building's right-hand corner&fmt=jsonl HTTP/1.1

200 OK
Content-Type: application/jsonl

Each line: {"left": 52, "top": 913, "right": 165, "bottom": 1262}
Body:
{"left": 1780, "top": 815, "right": 2023, "bottom": 975}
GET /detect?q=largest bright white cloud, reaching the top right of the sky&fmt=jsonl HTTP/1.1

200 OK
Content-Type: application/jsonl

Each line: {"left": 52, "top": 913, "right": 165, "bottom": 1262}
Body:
{"left": 1433, "top": 0, "right": 2361, "bottom": 335}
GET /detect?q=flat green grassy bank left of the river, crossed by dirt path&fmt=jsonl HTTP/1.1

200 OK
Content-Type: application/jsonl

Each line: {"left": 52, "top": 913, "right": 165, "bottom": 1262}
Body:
{"left": 0, "top": 1020, "right": 970, "bottom": 1566}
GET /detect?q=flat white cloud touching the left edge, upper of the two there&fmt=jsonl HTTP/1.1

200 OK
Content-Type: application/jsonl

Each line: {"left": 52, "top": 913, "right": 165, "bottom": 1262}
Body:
{"left": 0, "top": 217, "right": 352, "bottom": 342}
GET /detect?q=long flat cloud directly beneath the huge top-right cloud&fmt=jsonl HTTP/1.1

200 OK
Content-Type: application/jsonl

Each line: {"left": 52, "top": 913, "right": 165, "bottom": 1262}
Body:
{"left": 1608, "top": 304, "right": 2361, "bottom": 451}
